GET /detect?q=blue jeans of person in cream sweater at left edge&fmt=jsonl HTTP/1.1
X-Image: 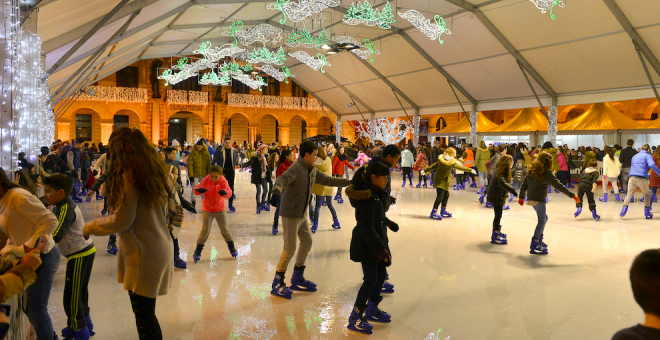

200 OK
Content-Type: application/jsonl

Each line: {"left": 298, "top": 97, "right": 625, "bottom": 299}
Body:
{"left": 25, "top": 246, "right": 60, "bottom": 340}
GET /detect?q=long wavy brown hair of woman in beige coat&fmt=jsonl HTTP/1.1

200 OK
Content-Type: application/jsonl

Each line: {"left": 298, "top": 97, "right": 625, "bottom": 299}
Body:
{"left": 106, "top": 127, "right": 173, "bottom": 209}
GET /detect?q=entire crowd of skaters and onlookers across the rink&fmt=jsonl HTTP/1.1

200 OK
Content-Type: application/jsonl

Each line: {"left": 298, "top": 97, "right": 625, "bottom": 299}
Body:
{"left": 0, "top": 128, "right": 660, "bottom": 340}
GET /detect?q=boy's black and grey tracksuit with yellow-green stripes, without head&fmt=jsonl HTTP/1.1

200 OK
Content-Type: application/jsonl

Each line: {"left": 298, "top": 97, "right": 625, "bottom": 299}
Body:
{"left": 53, "top": 197, "right": 96, "bottom": 331}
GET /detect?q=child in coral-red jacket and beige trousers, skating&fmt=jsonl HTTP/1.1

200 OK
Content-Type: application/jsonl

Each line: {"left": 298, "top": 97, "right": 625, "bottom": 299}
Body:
{"left": 193, "top": 165, "right": 238, "bottom": 263}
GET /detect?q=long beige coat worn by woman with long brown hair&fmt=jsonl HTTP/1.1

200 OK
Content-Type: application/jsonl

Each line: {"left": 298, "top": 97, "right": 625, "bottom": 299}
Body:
{"left": 84, "top": 183, "right": 174, "bottom": 298}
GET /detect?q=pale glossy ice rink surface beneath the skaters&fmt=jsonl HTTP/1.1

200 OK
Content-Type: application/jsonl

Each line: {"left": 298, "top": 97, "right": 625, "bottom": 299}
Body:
{"left": 49, "top": 172, "right": 660, "bottom": 340}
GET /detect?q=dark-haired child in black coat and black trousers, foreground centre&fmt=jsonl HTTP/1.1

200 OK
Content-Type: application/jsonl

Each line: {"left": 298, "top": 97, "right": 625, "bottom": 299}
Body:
{"left": 346, "top": 162, "right": 392, "bottom": 334}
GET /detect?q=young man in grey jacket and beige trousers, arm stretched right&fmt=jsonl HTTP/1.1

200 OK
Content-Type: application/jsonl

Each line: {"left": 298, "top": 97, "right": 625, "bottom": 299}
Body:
{"left": 270, "top": 141, "right": 349, "bottom": 299}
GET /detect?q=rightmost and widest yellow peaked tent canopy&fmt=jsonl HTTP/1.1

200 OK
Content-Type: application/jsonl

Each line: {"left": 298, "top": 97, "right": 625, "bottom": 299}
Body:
{"left": 557, "top": 103, "right": 641, "bottom": 135}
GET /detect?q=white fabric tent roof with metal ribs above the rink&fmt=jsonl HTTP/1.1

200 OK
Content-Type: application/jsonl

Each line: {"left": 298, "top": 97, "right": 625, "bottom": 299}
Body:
{"left": 38, "top": 0, "right": 660, "bottom": 120}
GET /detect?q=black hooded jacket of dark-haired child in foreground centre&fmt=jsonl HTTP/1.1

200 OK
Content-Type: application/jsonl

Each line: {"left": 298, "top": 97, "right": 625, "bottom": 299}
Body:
{"left": 346, "top": 184, "right": 389, "bottom": 263}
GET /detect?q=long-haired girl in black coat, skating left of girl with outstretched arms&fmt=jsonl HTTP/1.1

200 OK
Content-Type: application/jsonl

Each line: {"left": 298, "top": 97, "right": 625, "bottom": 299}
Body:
{"left": 486, "top": 155, "right": 518, "bottom": 244}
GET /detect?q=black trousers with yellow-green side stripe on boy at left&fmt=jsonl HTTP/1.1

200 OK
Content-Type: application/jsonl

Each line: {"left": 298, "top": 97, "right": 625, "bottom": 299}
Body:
{"left": 64, "top": 253, "right": 95, "bottom": 331}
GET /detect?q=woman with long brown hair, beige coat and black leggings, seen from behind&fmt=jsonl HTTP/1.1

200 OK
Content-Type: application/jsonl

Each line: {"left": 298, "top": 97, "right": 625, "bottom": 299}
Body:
{"left": 83, "top": 127, "right": 175, "bottom": 339}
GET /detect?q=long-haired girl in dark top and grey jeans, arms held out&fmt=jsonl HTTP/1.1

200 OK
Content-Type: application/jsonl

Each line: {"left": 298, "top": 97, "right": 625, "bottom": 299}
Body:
{"left": 518, "top": 151, "right": 580, "bottom": 255}
